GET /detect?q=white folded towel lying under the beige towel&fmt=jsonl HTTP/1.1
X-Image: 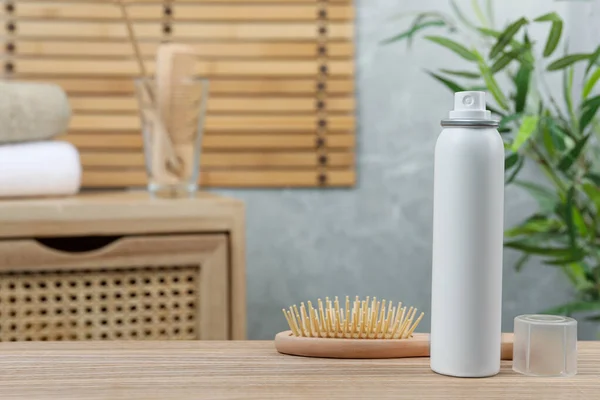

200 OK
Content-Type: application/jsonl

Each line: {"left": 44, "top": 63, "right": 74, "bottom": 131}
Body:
{"left": 0, "top": 141, "right": 81, "bottom": 197}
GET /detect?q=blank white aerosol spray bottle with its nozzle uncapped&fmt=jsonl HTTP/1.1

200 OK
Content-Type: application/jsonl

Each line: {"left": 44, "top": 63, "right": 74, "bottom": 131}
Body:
{"left": 430, "top": 92, "right": 504, "bottom": 377}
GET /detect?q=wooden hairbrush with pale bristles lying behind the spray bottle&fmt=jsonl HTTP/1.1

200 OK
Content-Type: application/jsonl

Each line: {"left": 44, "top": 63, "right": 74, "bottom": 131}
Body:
{"left": 275, "top": 296, "right": 513, "bottom": 360}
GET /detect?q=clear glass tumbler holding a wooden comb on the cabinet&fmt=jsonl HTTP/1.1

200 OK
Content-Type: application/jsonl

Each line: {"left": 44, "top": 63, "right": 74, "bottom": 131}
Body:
{"left": 135, "top": 78, "right": 208, "bottom": 197}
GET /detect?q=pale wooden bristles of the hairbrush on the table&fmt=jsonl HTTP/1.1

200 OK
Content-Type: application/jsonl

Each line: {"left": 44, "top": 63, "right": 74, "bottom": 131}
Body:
{"left": 283, "top": 296, "right": 425, "bottom": 339}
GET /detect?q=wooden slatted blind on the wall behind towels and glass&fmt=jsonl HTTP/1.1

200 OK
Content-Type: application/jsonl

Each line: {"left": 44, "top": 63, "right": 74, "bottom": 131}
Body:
{"left": 0, "top": 0, "right": 356, "bottom": 188}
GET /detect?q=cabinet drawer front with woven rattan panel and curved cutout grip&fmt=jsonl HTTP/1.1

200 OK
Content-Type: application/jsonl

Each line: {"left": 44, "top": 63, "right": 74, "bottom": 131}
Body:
{"left": 0, "top": 234, "right": 230, "bottom": 341}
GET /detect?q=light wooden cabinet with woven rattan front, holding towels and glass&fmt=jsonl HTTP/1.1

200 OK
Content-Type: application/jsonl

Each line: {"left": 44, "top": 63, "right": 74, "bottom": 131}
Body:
{"left": 0, "top": 192, "right": 246, "bottom": 341}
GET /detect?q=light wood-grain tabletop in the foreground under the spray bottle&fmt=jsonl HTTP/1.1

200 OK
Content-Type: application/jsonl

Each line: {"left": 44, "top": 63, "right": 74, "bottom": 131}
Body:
{"left": 0, "top": 341, "right": 600, "bottom": 400}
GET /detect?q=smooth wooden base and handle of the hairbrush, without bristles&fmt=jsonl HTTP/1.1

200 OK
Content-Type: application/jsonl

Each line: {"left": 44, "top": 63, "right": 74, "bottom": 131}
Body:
{"left": 275, "top": 331, "right": 513, "bottom": 360}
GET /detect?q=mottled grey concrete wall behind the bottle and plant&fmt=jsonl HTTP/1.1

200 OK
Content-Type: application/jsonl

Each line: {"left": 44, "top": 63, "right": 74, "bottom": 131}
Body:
{"left": 216, "top": 0, "right": 598, "bottom": 339}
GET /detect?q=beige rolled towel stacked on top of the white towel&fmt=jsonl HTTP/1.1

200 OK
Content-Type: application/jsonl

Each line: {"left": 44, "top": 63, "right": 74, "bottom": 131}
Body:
{"left": 0, "top": 81, "right": 71, "bottom": 144}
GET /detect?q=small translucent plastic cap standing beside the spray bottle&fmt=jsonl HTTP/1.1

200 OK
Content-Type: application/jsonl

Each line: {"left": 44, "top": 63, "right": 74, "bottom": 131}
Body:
{"left": 513, "top": 315, "right": 577, "bottom": 376}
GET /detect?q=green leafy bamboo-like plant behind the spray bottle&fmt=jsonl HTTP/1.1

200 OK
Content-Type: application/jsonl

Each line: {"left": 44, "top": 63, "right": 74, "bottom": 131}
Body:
{"left": 385, "top": 1, "right": 600, "bottom": 320}
